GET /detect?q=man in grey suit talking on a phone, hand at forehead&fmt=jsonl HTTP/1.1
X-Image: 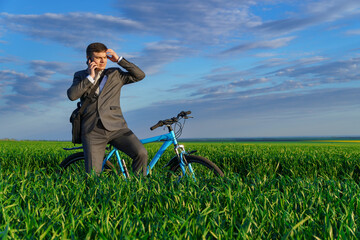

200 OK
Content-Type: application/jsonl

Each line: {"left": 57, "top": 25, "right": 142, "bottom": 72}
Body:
{"left": 67, "top": 43, "right": 148, "bottom": 176}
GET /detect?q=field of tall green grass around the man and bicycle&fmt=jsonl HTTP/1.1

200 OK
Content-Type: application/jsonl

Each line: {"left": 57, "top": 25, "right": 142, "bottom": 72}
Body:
{"left": 0, "top": 141, "right": 360, "bottom": 239}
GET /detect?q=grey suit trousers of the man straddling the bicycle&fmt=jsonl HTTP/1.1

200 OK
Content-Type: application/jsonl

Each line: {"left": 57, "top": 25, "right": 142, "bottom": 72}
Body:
{"left": 82, "top": 119, "right": 148, "bottom": 176}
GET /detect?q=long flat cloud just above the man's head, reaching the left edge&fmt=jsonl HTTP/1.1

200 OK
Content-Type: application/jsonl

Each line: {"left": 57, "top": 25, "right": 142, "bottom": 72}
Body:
{"left": 0, "top": 12, "right": 142, "bottom": 48}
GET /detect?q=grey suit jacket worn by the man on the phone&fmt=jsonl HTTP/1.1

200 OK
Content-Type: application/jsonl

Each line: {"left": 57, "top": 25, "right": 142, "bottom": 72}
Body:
{"left": 67, "top": 58, "right": 145, "bottom": 134}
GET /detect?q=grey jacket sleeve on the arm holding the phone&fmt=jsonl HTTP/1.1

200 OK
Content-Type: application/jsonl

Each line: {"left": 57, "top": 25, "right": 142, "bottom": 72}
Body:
{"left": 67, "top": 72, "right": 94, "bottom": 101}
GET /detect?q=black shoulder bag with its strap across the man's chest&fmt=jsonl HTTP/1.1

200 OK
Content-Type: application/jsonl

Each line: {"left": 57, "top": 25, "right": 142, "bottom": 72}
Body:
{"left": 70, "top": 69, "right": 107, "bottom": 144}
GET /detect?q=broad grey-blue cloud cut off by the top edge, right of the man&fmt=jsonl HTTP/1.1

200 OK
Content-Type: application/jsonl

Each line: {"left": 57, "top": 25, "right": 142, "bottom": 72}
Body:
{"left": 118, "top": 0, "right": 260, "bottom": 45}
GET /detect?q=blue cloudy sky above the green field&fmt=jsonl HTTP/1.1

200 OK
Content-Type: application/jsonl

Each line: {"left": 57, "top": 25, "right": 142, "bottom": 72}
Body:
{"left": 0, "top": 0, "right": 360, "bottom": 140}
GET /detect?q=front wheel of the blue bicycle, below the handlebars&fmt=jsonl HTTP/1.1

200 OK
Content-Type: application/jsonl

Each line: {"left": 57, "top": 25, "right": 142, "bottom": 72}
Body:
{"left": 170, "top": 155, "right": 224, "bottom": 179}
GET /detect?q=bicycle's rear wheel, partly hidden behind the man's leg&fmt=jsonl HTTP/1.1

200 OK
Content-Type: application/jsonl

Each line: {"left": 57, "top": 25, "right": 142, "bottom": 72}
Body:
{"left": 60, "top": 152, "right": 115, "bottom": 173}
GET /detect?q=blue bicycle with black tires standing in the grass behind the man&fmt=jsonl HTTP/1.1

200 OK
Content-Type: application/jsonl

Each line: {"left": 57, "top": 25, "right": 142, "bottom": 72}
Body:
{"left": 60, "top": 111, "right": 224, "bottom": 181}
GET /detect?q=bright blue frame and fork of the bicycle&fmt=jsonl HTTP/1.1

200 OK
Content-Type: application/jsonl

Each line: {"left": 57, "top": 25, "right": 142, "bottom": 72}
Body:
{"left": 102, "top": 129, "right": 195, "bottom": 180}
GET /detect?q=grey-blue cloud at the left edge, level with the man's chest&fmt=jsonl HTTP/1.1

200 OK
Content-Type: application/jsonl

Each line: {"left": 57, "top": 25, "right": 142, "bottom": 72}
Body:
{"left": 0, "top": 60, "right": 70, "bottom": 112}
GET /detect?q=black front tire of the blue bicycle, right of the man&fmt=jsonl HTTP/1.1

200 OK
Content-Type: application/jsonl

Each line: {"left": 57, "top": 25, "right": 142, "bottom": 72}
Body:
{"left": 170, "top": 155, "right": 224, "bottom": 178}
